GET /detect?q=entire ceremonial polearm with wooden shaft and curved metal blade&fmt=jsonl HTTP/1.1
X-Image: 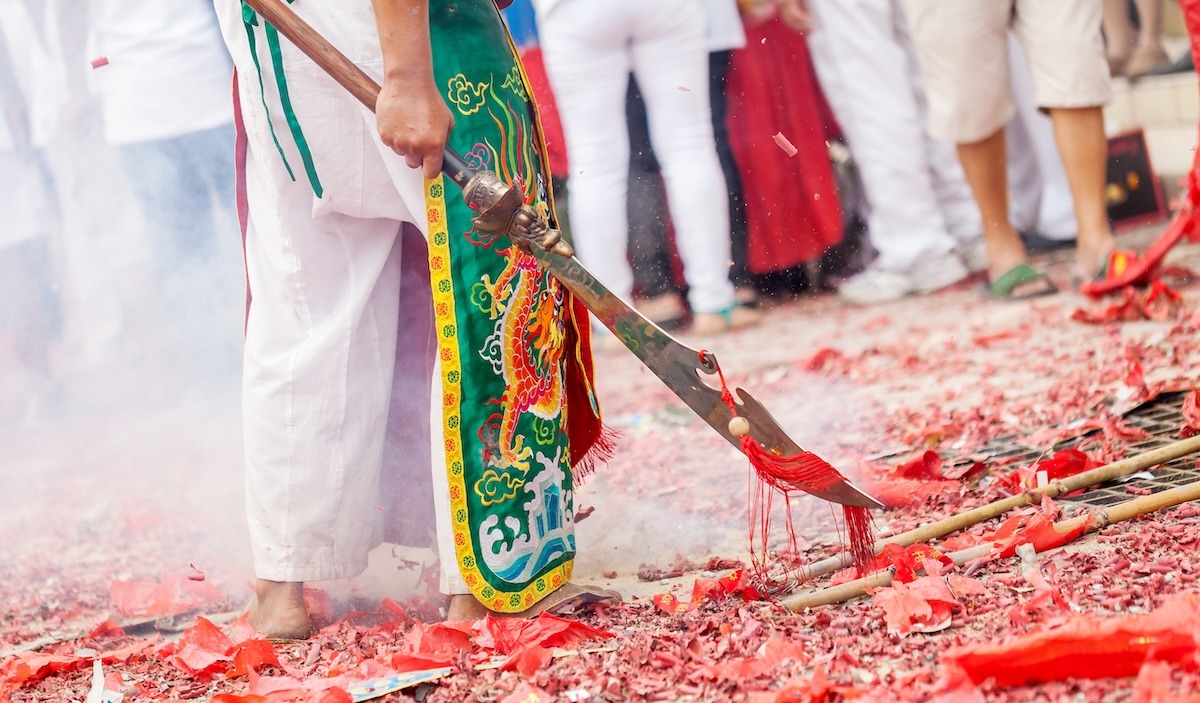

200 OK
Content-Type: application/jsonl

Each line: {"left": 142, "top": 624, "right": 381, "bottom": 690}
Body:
{"left": 245, "top": 0, "right": 883, "bottom": 507}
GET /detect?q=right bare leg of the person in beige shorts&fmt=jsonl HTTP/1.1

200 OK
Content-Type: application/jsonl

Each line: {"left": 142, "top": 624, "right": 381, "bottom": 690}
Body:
{"left": 1050, "top": 108, "right": 1116, "bottom": 275}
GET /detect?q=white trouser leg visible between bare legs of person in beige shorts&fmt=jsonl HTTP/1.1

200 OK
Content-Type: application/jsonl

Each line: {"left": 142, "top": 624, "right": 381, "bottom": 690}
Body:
{"left": 1006, "top": 32, "right": 1079, "bottom": 240}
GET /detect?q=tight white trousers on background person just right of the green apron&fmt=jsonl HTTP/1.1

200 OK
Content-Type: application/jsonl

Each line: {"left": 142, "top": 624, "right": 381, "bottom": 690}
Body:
{"left": 538, "top": 0, "right": 733, "bottom": 313}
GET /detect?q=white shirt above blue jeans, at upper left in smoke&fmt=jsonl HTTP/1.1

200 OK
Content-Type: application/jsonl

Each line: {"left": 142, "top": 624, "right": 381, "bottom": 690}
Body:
{"left": 88, "top": 0, "right": 233, "bottom": 144}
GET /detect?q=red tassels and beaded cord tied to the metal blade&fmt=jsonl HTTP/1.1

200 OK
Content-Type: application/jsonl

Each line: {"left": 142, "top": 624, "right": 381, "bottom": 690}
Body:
{"left": 701, "top": 352, "right": 875, "bottom": 575}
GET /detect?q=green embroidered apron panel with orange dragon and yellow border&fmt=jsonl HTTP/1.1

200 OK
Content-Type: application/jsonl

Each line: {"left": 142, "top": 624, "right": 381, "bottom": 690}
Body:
{"left": 426, "top": 0, "right": 598, "bottom": 612}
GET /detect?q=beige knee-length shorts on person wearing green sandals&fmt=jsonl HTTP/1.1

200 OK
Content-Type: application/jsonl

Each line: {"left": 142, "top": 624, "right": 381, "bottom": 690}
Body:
{"left": 904, "top": 0, "right": 1112, "bottom": 144}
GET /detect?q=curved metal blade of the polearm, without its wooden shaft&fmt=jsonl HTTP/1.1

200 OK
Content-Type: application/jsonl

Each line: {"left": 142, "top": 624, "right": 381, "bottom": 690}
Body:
{"left": 533, "top": 250, "right": 883, "bottom": 507}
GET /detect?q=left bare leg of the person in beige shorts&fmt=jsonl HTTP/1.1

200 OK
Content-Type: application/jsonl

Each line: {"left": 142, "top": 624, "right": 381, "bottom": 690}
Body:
{"left": 959, "top": 130, "right": 1028, "bottom": 284}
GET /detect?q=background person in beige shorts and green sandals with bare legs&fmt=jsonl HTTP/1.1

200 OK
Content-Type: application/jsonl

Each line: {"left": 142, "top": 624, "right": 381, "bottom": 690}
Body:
{"left": 905, "top": 0, "right": 1116, "bottom": 299}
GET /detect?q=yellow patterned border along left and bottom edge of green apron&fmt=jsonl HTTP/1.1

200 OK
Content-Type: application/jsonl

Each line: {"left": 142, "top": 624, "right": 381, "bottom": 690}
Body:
{"left": 425, "top": 175, "right": 575, "bottom": 613}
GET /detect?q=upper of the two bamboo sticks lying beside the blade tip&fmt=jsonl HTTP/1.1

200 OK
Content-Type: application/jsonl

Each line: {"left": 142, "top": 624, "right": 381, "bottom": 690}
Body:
{"left": 800, "top": 435, "right": 1200, "bottom": 578}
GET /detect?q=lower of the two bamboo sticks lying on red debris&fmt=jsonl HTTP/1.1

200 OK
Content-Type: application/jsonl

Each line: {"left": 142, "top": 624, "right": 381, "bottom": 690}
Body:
{"left": 782, "top": 475, "right": 1200, "bottom": 612}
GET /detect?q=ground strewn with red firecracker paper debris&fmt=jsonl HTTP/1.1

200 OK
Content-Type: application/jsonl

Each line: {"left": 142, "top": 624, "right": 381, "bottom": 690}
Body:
{"left": 7, "top": 227, "right": 1200, "bottom": 703}
